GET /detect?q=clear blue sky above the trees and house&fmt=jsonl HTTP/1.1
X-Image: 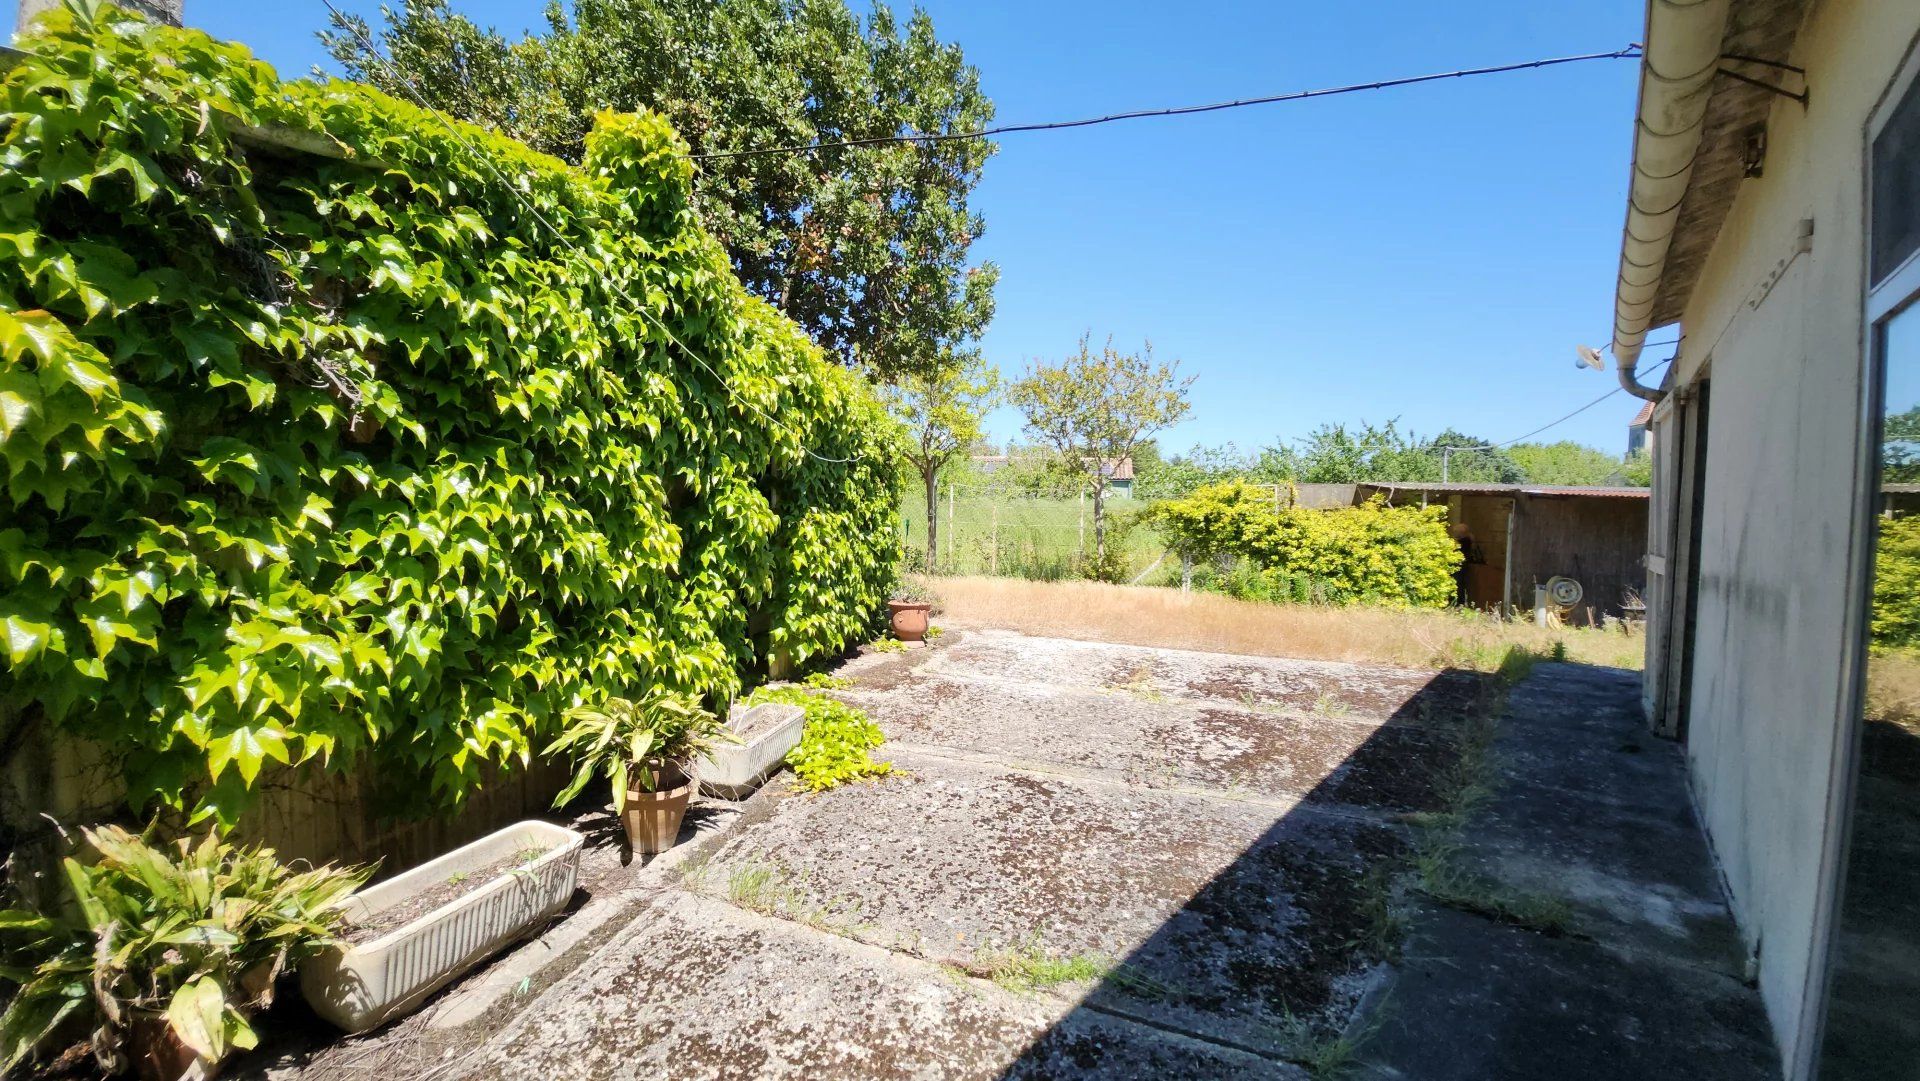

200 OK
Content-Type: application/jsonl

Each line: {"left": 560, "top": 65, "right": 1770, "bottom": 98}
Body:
{"left": 0, "top": 0, "right": 1663, "bottom": 453}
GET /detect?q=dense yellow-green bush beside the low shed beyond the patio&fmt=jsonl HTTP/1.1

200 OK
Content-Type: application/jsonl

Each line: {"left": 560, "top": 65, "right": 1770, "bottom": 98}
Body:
{"left": 1146, "top": 482, "right": 1461, "bottom": 609}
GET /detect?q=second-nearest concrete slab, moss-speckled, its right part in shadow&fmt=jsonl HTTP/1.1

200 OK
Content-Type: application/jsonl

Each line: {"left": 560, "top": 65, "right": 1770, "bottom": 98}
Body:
{"left": 695, "top": 755, "right": 1404, "bottom": 1052}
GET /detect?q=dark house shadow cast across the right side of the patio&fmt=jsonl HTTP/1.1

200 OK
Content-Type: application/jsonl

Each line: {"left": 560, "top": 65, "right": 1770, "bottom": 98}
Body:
{"left": 1002, "top": 664, "right": 1780, "bottom": 1081}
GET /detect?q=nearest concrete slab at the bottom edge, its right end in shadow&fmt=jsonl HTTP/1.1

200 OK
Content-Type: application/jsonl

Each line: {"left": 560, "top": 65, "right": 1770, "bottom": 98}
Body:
{"left": 459, "top": 893, "right": 1300, "bottom": 1081}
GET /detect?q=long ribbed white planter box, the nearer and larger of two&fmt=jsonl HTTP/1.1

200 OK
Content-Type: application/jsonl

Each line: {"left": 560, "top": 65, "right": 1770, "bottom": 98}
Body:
{"left": 300, "top": 820, "right": 584, "bottom": 1033}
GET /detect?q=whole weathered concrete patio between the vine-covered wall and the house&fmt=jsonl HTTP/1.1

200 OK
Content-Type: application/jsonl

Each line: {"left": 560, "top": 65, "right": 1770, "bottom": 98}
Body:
{"left": 247, "top": 630, "right": 1778, "bottom": 1081}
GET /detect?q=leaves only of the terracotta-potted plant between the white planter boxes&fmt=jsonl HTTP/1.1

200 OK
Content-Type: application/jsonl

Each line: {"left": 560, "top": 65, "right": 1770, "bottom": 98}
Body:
{"left": 545, "top": 691, "right": 739, "bottom": 814}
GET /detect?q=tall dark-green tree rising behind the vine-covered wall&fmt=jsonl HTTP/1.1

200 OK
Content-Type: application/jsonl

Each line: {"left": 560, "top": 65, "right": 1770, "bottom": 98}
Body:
{"left": 321, "top": 0, "right": 998, "bottom": 380}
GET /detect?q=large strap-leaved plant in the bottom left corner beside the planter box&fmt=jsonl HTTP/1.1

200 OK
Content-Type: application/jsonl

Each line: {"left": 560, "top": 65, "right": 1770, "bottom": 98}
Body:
{"left": 0, "top": 826, "right": 372, "bottom": 1073}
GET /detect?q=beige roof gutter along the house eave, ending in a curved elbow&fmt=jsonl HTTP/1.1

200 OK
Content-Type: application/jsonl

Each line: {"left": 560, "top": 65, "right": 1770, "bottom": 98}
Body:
{"left": 1613, "top": 0, "right": 1732, "bottom": 401}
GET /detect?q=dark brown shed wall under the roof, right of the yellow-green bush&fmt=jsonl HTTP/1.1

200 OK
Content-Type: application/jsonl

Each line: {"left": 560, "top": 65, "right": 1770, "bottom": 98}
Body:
{"left": 1513, "top": 495, "right": 1647, "bottom": 626}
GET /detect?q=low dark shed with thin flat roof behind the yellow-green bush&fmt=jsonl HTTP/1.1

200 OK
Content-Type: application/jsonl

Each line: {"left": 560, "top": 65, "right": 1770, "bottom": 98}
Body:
{"left": 1354, "top": 482, "right": 1647, "bottom": 626}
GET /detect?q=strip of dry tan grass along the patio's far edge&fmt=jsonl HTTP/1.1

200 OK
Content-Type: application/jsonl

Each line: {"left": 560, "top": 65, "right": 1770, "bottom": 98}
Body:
{"left": 931, "top": 578, "right": 1645, "bottom": 672}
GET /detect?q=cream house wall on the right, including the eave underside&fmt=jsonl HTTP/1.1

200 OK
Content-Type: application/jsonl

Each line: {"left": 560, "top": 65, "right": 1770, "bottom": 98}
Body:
{"left": 1678, "top": 0, "right": 1920, "bottom": 1077}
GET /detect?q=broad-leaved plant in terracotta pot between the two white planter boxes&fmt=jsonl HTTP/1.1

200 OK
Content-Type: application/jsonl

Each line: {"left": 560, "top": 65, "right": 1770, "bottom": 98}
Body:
{"left": 547, "top": 691, "right": 737, "bottom": 854}
